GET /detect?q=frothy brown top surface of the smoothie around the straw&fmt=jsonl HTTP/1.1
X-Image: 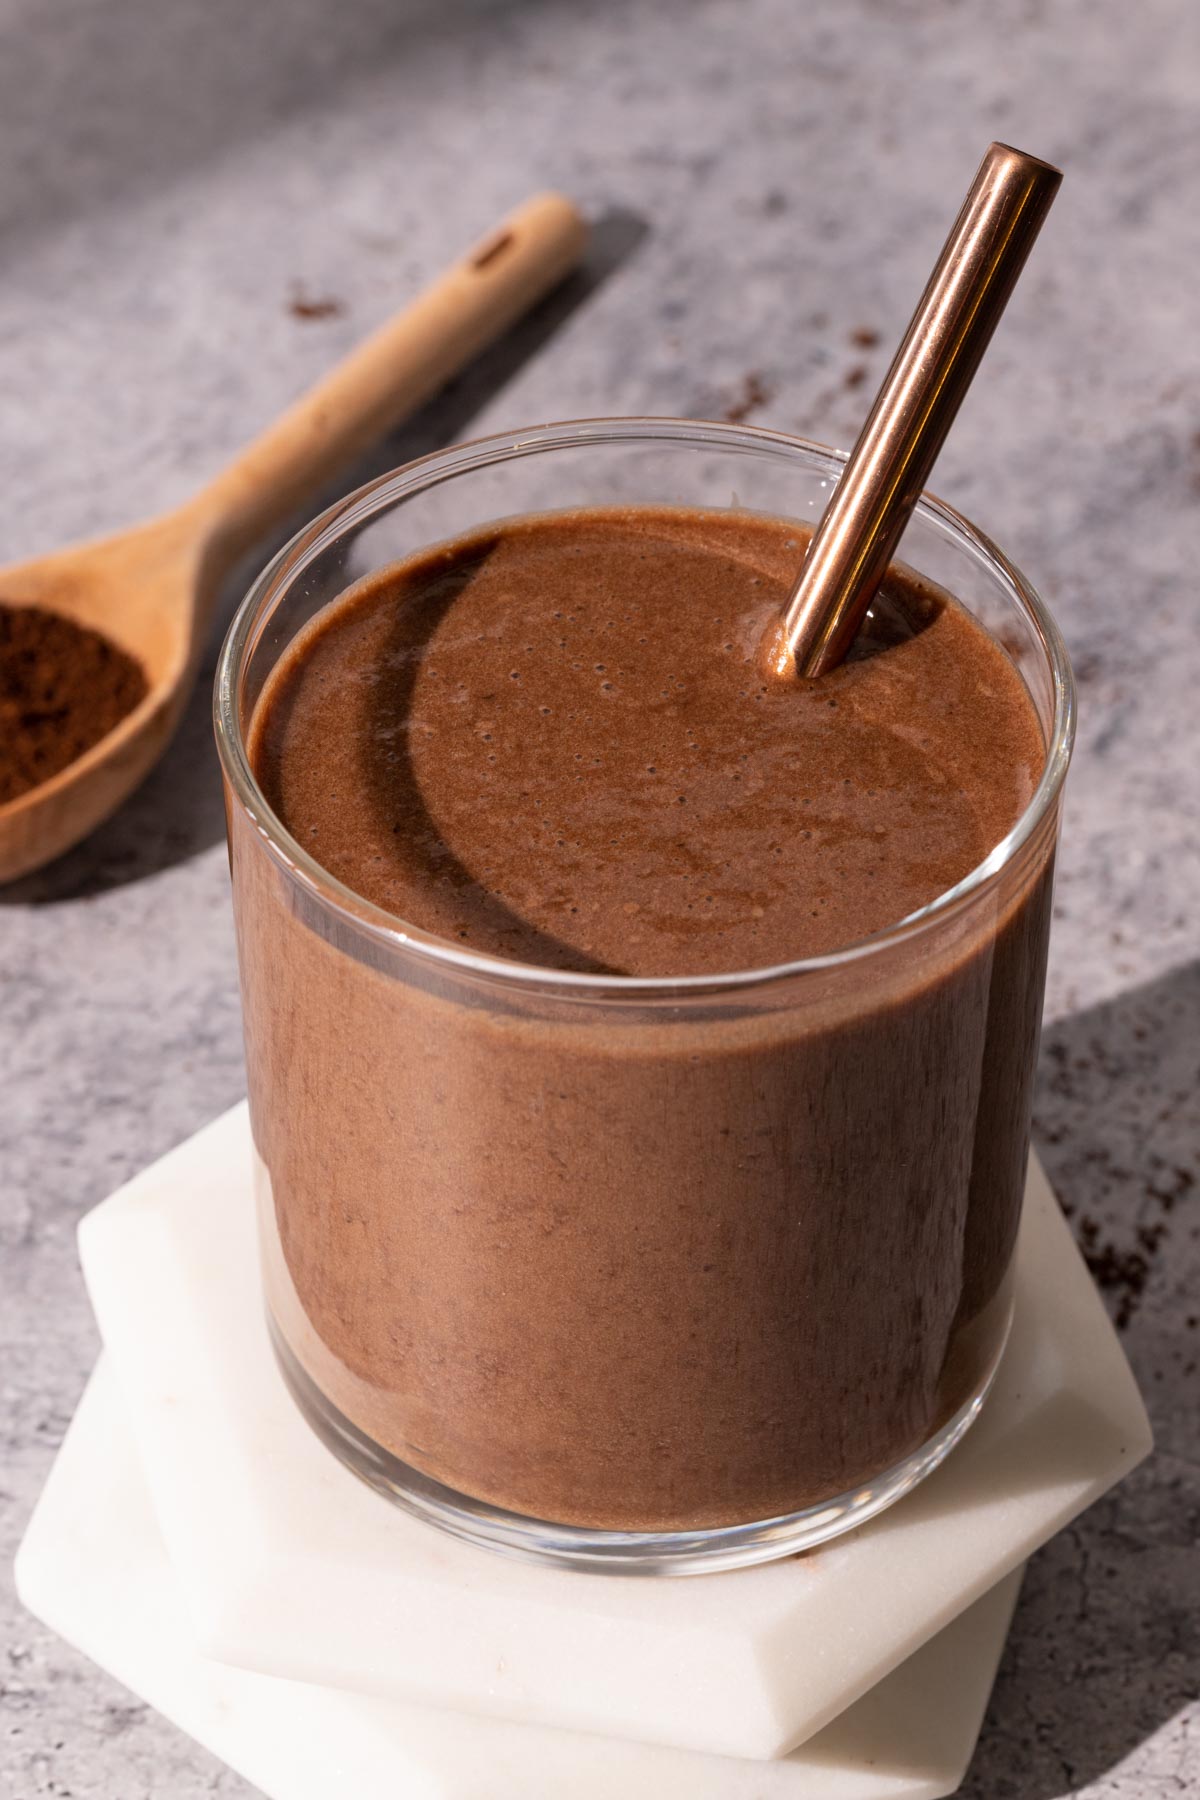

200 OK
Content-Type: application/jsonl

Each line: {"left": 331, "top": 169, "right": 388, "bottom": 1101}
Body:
{"left": 254, "top": 508, "right": 1043, "bottom": 976}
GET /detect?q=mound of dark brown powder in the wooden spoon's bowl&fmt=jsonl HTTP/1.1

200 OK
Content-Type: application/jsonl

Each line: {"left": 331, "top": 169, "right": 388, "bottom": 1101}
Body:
{"left": 0, "top": 601, "right": 146, "bottom": 806}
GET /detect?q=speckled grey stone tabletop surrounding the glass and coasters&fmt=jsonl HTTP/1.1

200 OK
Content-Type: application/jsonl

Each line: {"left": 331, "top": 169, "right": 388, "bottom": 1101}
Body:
{"left": 0, "top": 0, "right": 1200, "bottom": 1800}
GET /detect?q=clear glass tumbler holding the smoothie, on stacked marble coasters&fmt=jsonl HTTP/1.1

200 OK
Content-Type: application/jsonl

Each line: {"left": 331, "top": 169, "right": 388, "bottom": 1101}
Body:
{"left": 216, "top": 419, "right": 1074, "bottom": 1573}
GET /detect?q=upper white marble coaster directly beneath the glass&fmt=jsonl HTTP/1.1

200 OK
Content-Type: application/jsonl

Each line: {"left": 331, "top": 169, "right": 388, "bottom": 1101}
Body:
{"left": 79, "top": 1107, "right": 1150, "bottom": 1757}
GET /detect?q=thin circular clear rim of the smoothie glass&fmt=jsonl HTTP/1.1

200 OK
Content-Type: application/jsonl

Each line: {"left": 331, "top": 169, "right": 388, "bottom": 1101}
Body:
{"left": 212, "top": 418, "right": 1076, "bottom": 1001}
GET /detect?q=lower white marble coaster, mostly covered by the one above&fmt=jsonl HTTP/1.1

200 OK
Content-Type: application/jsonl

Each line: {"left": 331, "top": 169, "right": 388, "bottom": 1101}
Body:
{"left": 16, "top": 1361, "right": 1020, "bottom": 1800}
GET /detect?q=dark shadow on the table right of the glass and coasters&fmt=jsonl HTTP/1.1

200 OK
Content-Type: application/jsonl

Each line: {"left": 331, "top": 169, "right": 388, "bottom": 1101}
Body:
{"left": 961, "top": 963, "right": 1200, "bottom": 1800}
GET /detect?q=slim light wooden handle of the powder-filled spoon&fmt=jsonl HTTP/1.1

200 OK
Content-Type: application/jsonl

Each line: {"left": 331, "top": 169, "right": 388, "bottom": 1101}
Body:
{"left": 194, "top": 194, "right": 587, "bottom": 560}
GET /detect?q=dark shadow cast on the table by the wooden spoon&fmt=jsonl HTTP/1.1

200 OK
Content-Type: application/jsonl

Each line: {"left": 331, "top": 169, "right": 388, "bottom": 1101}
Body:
{"left": 0, "top": 211, "right": 648, "bottom": 905}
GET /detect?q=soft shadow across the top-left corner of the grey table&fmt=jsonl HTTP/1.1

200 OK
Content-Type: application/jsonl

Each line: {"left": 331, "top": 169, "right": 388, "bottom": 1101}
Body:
{"left": 0, "top": 0, "right": 582, "bottom": 256}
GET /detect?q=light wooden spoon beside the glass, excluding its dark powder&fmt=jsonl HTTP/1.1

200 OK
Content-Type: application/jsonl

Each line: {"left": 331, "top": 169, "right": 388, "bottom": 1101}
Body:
{"left": 0, "top": 194, "right": 587, "bottom": 882}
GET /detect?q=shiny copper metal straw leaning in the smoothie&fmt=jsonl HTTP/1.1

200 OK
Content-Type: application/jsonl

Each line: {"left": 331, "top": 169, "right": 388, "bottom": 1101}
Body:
{"left": 765, "top": 144, "right": 1061, "bottom": 679}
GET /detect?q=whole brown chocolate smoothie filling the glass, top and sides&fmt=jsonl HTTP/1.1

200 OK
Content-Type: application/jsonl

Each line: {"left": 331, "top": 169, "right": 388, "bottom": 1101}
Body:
{"left": 230, "top": 508, "right": 1052, "bottom": 1530}
